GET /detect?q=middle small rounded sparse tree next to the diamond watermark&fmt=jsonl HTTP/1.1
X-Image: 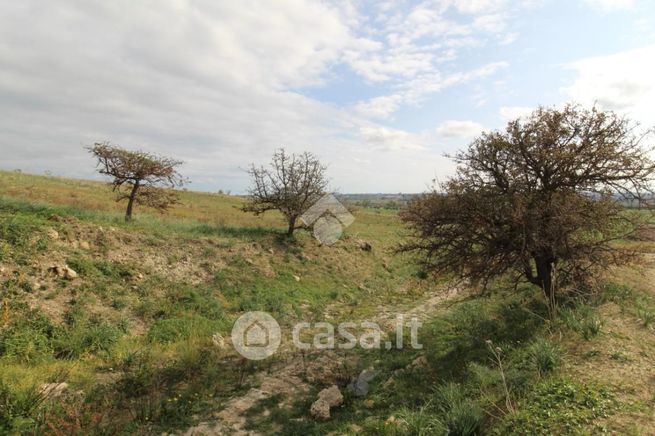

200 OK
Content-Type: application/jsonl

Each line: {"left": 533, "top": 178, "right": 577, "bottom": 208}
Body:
{"left": 242, "top": 149, "right": 328, "bottom": 236}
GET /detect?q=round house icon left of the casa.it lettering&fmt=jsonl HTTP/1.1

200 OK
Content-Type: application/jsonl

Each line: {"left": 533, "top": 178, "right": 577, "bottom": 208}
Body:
{"left": 232, "top": 312, "right": 282, "bottom": 360}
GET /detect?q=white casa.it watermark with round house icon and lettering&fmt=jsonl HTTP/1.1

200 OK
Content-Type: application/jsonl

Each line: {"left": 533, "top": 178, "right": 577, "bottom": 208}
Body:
{"left": 232, "top": 312, "right": 423, "bottom": 360}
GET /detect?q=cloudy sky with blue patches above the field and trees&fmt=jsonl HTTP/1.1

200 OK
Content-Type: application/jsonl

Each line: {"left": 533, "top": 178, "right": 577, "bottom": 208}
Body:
{"left": 0, "top": 0, "right": 655, "bottom": 193}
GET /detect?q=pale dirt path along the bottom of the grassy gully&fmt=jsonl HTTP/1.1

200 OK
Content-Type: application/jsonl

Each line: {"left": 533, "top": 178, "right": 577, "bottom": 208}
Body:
{"left": 184, "top": 287, "right": 459, "bottom": 436}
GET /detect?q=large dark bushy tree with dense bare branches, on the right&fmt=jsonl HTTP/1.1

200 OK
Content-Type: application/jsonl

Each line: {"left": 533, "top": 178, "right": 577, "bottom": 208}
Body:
{"left": 400, "top": 105, "right": 655, "bottom": 309}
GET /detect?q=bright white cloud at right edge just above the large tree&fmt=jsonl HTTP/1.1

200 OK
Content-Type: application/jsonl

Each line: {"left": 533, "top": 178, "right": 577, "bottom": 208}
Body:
{"left": 562, "top": 45, "right": 655, "bottom": 124}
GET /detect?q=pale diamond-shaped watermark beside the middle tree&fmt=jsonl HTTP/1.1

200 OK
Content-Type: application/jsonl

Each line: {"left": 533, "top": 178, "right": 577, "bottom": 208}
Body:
{"left": 300, "top": 194, "right": 355, "bottom": 245}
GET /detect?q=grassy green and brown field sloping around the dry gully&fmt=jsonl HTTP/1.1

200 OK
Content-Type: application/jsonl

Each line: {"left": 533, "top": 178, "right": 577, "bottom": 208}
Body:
{"left": 0, "top": 172, "right": 655, "bottom": 435}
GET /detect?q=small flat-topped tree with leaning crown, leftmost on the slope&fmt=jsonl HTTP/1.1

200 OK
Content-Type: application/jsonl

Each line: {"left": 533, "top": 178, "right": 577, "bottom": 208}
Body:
{"left": 88, "top": 142, "right": 187, "bottom": 221}
